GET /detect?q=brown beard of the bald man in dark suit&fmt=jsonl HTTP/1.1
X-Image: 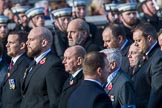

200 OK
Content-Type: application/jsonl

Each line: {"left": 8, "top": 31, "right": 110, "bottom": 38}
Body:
{"left": 27, "top": 48, "right": 41, "bottom": 57}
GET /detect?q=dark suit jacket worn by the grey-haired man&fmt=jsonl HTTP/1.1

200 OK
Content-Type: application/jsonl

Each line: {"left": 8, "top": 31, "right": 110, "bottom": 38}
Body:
{"left": 105, "top": 70, "right": 136, "bottom": 108}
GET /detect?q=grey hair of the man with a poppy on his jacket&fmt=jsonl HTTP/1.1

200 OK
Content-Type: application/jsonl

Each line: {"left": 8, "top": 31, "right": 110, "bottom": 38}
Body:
{"left": 100, "top": 48, "right": 122, "bottom": 67}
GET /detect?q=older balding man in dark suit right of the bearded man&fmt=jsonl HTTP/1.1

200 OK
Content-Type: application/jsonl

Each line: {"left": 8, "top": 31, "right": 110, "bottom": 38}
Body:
{"left": 59, "top": 45, "right": 86, "bottom": 108}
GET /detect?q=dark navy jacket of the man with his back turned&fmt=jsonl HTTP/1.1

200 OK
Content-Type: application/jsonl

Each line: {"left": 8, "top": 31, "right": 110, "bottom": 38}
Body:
{"left": 68, "top": 80, "right": 112, "bottom": 108}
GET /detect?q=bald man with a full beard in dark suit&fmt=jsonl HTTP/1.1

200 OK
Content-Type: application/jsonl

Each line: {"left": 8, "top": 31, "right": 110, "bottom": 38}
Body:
{"left": 20, "top": 27, "right": 67, "bottom": 108}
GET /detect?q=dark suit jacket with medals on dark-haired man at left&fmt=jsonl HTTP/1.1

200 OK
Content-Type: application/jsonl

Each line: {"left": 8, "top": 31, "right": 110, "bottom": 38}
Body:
{"left": 2, "top": 54, "right": 31, "bottom": 108}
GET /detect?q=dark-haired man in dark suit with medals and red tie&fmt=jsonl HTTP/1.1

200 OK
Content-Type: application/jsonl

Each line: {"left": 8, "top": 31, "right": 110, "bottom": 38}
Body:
{"left": 2, "top": 31, "right": 31, "bottom": 108}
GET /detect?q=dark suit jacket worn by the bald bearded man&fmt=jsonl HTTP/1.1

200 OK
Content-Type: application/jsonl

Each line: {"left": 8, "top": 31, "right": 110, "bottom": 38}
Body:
{"left": 20, "top": 52, "right": 67, "bottom": 108}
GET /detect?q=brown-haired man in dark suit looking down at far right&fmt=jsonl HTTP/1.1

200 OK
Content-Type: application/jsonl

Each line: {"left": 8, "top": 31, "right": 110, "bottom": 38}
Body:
{"left": 132, "top": 23, "right": 162, "bottom": 108}
